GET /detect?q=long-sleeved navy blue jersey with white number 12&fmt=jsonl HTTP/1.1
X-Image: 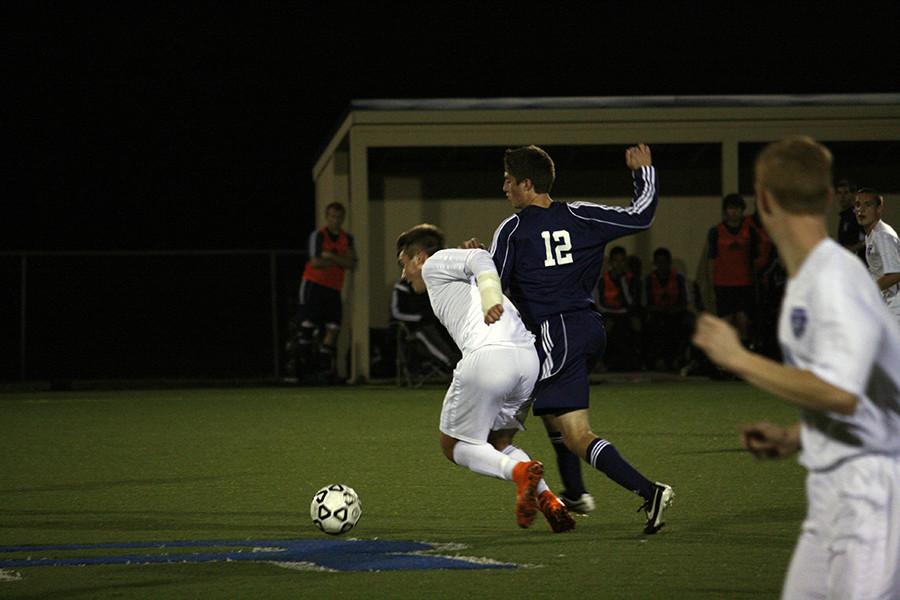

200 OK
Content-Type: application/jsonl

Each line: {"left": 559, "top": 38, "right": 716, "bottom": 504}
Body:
{"left": 491, "top": 166, "right": 659, "bottom": 331}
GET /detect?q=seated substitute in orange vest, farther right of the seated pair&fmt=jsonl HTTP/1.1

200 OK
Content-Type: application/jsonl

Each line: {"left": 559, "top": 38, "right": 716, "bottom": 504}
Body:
{"left": 644, "top": 248, "right": 693, "bottom": 371}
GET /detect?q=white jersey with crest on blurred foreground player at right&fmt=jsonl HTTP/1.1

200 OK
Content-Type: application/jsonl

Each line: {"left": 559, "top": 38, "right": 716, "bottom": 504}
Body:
{"left": 778, "top": 239, "right": 900, "bottom": 471}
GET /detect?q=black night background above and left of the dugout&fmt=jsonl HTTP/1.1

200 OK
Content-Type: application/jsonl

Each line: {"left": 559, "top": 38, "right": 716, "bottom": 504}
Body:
{"left": 0, "top": 1, "right": 900, "bottom": 380}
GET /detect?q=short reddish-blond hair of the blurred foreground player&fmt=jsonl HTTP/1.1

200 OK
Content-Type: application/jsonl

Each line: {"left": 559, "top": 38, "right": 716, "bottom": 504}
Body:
{"left": 755, "top": 135, "right": 833, "bottom": 214}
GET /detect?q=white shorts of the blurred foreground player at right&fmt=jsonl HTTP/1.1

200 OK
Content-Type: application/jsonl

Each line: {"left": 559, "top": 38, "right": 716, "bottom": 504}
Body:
{"left": 782, "top": 455, "right": 900, "bottom": 600}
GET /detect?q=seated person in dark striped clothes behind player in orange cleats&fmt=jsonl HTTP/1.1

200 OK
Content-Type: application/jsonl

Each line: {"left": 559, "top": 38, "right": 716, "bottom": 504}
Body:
{"left": 391, "top": 279, "right": 461, "bottom": 373}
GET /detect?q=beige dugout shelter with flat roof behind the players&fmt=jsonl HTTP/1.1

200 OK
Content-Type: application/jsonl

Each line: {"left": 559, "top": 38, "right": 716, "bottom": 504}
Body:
{"left": 312, "top": 94, "right": 900, "bottom": 381}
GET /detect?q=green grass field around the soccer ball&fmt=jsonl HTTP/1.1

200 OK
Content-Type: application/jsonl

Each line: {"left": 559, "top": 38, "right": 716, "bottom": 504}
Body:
{"left": 0, "top": 382, "right": 805, "bottom": 599}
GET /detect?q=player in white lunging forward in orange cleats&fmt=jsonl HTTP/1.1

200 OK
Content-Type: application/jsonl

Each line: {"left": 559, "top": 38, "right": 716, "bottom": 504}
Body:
{"left": 397, "top": 224, "right": 575, "bottom": 533}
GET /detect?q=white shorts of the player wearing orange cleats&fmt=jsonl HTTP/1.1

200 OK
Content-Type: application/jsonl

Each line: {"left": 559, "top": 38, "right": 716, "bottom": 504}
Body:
{"left": 440, "top": 346, "right": 539, "bottom": 444}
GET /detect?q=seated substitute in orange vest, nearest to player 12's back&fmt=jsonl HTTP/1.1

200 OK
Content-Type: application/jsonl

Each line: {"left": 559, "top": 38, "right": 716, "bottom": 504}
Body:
{"left": 597, "top": 246, "right": 642, "bottom": 371}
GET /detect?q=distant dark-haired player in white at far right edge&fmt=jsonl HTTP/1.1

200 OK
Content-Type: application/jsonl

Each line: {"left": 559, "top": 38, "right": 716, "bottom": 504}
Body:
{"left": 855, "top": 188, "right": 900, "bottom": 323}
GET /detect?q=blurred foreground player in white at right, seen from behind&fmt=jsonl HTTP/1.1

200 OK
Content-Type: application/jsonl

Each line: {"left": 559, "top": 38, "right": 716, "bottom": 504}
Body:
{"left": 694, "top": 137, "right": 900, "bottom": 600}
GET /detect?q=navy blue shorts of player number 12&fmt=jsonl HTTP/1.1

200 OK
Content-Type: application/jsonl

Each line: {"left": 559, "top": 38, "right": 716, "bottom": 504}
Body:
{"left": 533, "top": 310, "right": 606, "bottom": 416}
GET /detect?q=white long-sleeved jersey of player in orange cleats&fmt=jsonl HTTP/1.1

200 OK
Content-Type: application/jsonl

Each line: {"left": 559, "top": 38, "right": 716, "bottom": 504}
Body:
{"left": 422, "top": 249, "right": 534, "bottom": 356}
